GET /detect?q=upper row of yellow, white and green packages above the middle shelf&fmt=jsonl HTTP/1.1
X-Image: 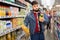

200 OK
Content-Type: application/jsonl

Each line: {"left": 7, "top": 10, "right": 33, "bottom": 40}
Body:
{"left": 0, "top": 5, "right": 25, "bottom": 17}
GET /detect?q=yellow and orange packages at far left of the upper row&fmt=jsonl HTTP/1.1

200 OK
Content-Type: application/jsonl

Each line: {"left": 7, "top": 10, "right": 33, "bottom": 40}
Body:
{"left": 0, "top": 5, "right": 11, "bottom": 17}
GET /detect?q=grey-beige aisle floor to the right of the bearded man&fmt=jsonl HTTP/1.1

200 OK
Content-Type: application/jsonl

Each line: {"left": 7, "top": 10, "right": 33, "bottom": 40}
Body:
{"left": 44, "top": 20, "right": 56, "bottom": 40}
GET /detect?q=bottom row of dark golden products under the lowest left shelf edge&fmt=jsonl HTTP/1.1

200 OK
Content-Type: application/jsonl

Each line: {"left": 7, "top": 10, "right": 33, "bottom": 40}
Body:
{"left": 0, "top": 29, "right": 24, "bottom": 40}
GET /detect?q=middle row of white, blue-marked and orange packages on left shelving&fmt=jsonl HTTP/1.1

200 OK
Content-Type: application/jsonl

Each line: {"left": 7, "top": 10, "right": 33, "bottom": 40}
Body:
{"left": 0, "top": 18, "right": 24, "bottom": 34}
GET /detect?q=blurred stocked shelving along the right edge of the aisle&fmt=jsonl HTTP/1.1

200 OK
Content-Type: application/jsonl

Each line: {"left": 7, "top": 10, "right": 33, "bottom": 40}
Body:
{"left": 54, "top": 16, "right": 60, "bottom": 40}
